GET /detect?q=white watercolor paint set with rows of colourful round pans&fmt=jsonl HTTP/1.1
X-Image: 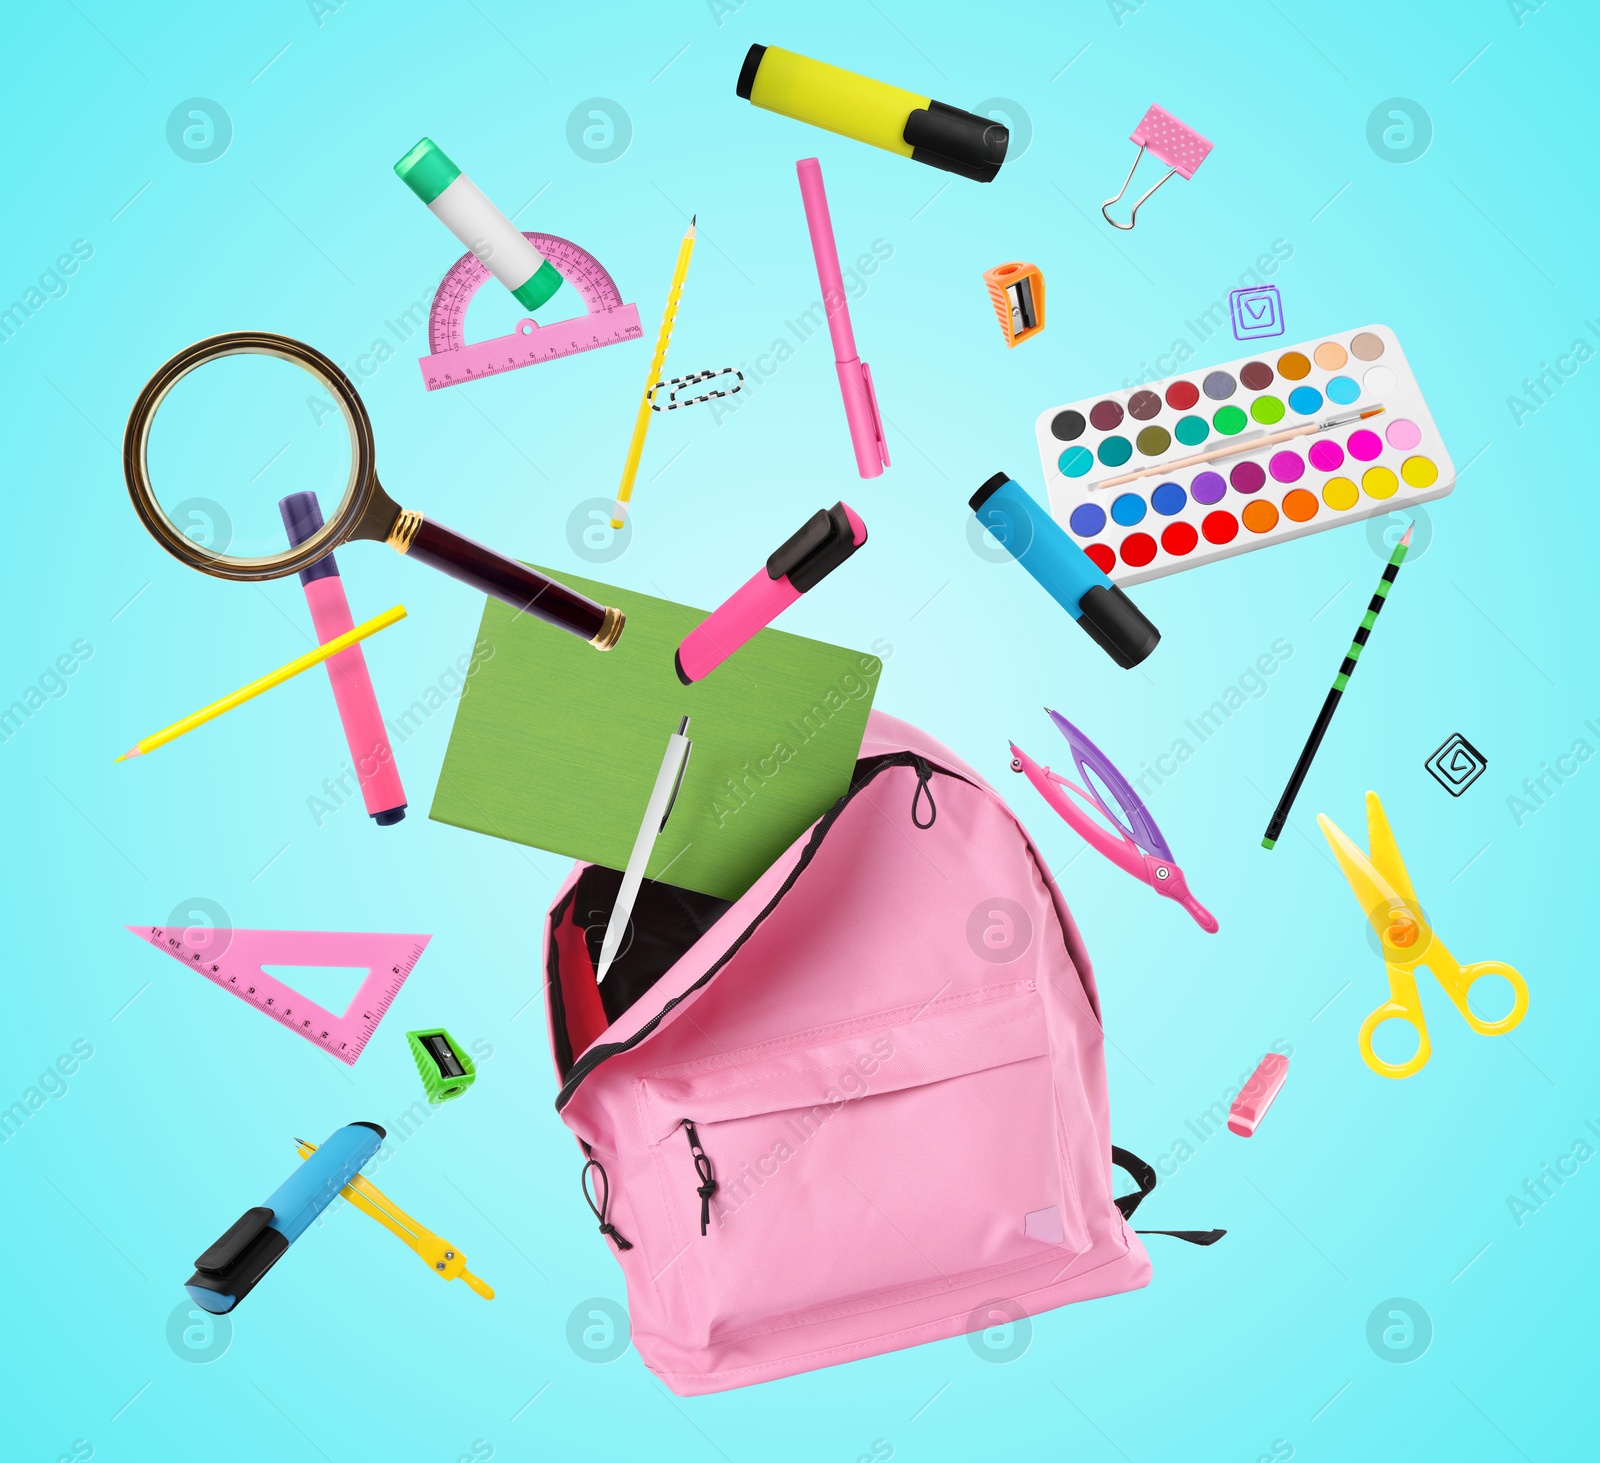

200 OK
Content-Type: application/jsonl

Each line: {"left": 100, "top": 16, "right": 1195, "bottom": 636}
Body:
{"left": 1035, "top": 325, "right": 1456, "bottom": 584}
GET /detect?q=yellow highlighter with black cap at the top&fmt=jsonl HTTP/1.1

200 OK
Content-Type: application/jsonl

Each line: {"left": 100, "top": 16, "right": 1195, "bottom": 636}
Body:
{"left": 738, "top": 46, "right": 1011, "bottom": 182}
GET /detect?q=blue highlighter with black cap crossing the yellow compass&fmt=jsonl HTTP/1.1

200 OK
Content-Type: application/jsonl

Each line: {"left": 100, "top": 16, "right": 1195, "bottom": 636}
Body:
{"left": 184, "top": 1122, "right": 386, "bottom": 1316}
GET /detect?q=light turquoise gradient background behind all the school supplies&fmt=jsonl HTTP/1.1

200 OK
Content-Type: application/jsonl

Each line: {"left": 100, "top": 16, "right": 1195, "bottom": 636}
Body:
{"left": 0, "top": 0, "right": 1600, "bottom": 1463}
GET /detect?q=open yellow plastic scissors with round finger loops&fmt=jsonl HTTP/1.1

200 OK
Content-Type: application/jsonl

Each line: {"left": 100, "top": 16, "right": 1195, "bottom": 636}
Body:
{"left": 1317, "top": 792, "right": 1528, "bottom": 1077}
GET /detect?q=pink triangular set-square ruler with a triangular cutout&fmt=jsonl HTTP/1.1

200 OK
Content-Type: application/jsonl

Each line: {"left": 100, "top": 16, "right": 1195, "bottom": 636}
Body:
{"left": 126, "top": 925, "right": 434, "bottom": 1066}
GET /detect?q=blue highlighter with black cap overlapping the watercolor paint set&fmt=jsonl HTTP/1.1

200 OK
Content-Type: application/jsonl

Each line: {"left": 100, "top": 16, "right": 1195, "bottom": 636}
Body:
{"left": 970, "top": 472, "right": 1162, "bottom": 671}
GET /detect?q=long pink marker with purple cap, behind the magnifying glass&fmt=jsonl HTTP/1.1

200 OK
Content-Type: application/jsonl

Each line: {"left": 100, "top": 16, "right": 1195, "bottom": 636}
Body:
{"left": 278, "top": 493, "right": 405, "bottom": 828}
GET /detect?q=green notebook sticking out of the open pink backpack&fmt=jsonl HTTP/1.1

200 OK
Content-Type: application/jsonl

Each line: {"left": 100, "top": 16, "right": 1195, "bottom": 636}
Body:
{"left": 429, "top": 570, "right": 883, "bottom": 900}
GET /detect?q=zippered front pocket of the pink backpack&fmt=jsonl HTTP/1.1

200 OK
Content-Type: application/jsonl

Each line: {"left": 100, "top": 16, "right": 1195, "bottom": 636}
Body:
{"left": 638, "top": 980, "right": 1088, "bottom": 1341}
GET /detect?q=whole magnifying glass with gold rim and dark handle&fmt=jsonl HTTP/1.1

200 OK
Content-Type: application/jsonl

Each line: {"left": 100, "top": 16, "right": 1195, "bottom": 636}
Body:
{"left": 122, "top": 330, "right": 624, "bottom": 650}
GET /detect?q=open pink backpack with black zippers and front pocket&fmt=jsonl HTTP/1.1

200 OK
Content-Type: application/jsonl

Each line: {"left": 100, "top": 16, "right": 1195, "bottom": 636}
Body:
{"left": 544, "top": 712, "right": 1219, "bottom": 1396}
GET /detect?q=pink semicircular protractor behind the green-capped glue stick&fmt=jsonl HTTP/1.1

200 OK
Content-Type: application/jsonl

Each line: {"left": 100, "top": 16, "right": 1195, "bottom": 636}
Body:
{"left": 419, "top": 234, "right": 640, "bottom": 391}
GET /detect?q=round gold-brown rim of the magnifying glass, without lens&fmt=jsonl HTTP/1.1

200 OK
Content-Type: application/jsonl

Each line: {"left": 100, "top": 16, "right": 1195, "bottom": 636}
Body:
{"left": 122, "top": 330, "right": 381, "bottom": 581}
